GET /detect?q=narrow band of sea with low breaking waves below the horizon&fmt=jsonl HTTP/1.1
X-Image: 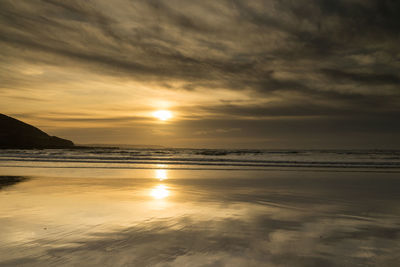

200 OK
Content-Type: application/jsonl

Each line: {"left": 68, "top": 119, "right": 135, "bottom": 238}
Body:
{"left": 0, "top": 149, "right": 400, "bottom": 169}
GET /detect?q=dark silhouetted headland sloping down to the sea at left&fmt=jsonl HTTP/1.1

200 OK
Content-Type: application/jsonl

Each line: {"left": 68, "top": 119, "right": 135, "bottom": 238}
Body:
{"left": 0, "top": 114, "right": 74, "bottom": 149}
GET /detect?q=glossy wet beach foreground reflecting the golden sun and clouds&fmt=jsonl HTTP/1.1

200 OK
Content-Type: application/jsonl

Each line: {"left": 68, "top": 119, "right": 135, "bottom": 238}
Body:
{"left": 0, "top": 150, "right": 400, "bottom": 266}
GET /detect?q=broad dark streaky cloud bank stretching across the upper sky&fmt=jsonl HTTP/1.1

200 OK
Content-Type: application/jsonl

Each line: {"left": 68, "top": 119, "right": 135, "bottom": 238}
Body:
{"left": 0, "top": 0, "right": 400, "bottom": 147}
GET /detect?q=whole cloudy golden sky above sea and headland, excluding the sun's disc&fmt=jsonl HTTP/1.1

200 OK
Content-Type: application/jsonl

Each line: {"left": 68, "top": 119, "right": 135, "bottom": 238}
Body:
{"left": 0, "top": 0, "right": 400, "bottom": 149}
